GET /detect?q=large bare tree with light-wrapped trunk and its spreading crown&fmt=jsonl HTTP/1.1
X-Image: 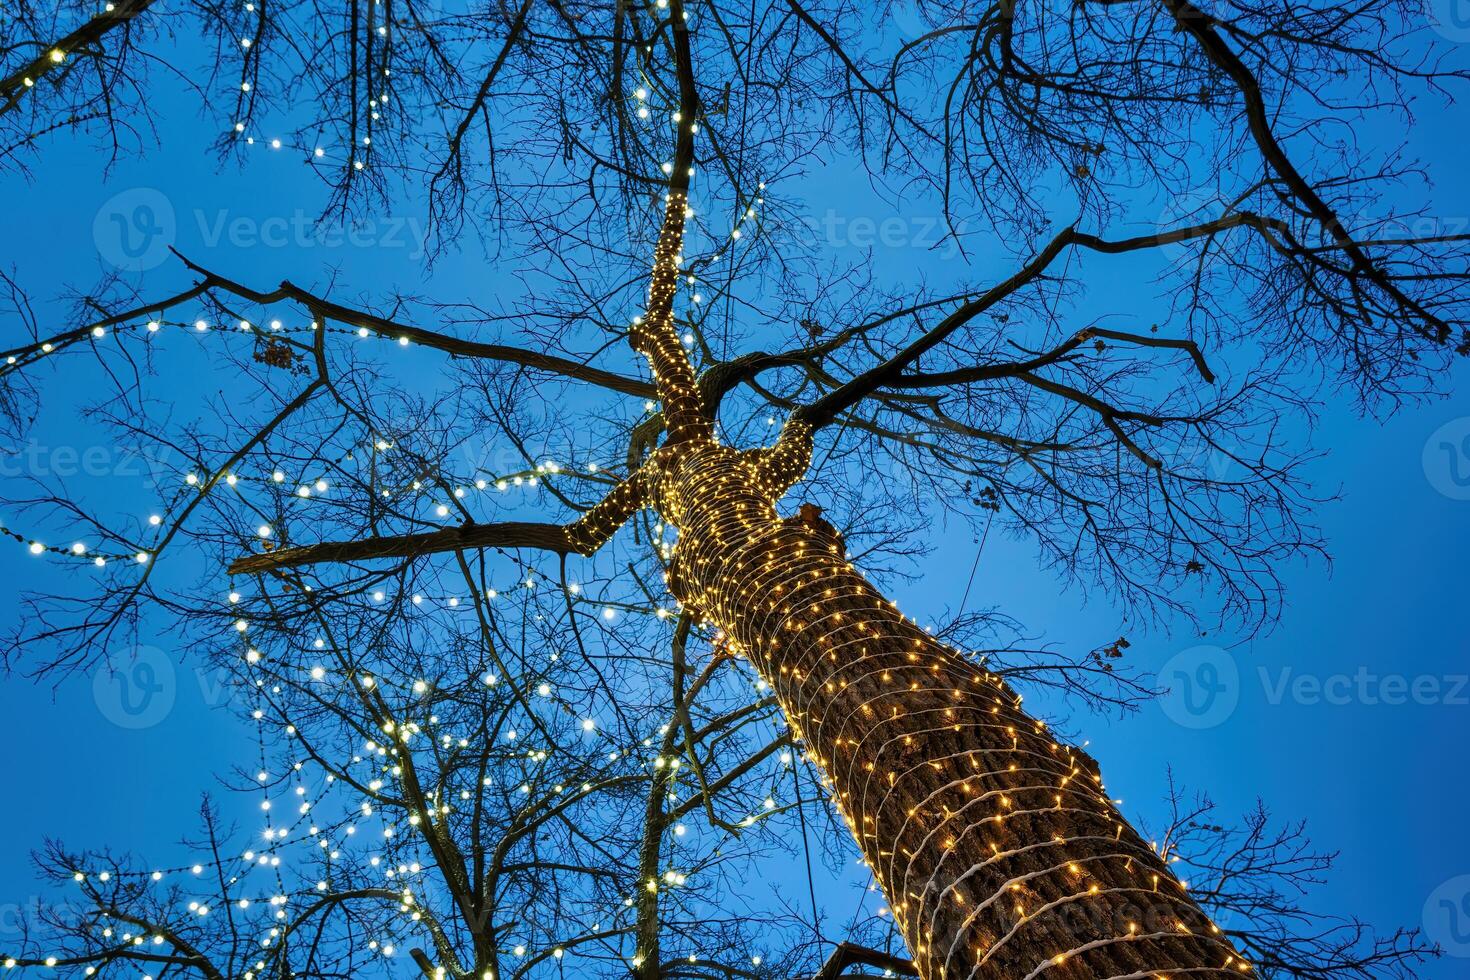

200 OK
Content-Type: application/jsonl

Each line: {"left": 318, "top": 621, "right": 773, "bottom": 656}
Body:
{"left": 6, "top": 0, "right": 1470, "bottom": 980}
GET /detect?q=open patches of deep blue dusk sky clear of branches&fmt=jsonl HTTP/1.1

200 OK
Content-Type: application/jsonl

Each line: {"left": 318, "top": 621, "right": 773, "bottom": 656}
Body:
{"left": 0, "top": 11, "right": 1470, "bottom": 979}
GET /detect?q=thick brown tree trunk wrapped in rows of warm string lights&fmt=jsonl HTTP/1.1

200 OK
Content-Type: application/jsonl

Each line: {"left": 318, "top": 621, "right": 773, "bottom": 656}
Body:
{"left": 654, "top": 442, "right": 1250, "bottom": 980}
